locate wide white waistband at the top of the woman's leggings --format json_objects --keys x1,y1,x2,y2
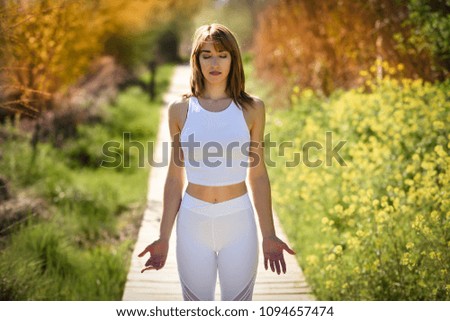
[{"x1": 180, "y1": 192, "x2": 253, "y2": 216}]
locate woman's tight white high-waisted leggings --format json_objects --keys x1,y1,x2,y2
[{"x1": 177, "y1": 192, "x2": 258, "y2": 301}]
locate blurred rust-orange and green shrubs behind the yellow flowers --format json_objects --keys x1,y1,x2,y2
[{"x1": 254, "y1": 0, "x2": 449, "y2": 94}]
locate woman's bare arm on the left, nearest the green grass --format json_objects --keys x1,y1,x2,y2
[{"x1": 139, "y1": 99, "x2": 184, "y2": 272}]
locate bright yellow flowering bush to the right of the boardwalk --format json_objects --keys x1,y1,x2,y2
[{"x1": 268, "y1": 61, "x2": 450, "y2": 300}]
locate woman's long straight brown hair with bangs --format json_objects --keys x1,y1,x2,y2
[{"x1": 184, "y1": 23, "x2": 254, "y2": 109}]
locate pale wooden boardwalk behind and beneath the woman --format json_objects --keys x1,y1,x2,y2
[{"x1": 123, "y1": 66, "x2": 314, "y2": 301}]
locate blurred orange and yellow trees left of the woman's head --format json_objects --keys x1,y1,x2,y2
[{"x1": 0, "y1": 0, "x2": 202, "y2": 116}]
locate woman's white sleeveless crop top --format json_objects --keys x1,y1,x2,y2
[{"x1": 180, "y1": 97, "x2": 250, "y2": 186}]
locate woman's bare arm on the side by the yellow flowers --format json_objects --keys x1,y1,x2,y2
[{"x1": 249, "y1": 99, "x2": 295, "y2": 274}]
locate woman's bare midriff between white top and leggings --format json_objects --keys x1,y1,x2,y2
[{"x1": 186, "y1": 181, "x2": 247, "y2": 204}]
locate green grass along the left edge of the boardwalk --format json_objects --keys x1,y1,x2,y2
[{"x1": 0, "y1": 66, "x2": 173, "y2": 300}]
